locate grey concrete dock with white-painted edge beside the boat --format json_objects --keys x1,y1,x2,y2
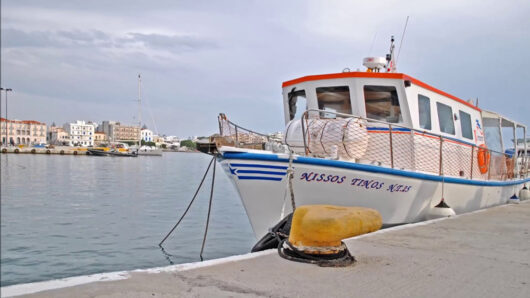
[{"x1": 2, "y1": 201, "x2": 530, "y2": 298}]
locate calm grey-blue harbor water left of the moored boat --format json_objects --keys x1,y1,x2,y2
[{"x1": 0, "y1": 153, "x2": 256, "y2": 286}]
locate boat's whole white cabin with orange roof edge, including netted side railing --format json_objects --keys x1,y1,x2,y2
[{"x1": 283, "y1": 71, "x2": 528, "y2": 180}]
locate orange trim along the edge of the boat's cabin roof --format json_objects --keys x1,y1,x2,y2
[{"x1": 282, "y1": 71, "x2": 481, "y2": 112}]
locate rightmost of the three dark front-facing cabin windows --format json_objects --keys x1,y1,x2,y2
[{"x1": 364, "y1": 85, "x2": 403, "y2": 123}]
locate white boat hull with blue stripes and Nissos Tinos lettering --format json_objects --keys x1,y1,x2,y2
[{"x1": 219, "y1": 151, "x2": 530, "y2": 238}]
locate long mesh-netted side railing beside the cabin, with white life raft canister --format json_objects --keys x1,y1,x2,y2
[{"x1": 299, "y1": 110, "x2": 528, "y2": 181}]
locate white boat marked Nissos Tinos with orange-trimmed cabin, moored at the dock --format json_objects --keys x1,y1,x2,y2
[{"x1": 196, "y1": 39, "x2": 530, "y2": 238}]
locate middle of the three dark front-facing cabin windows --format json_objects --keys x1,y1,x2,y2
[{"x1": 316, "y1": 86, "x2": 351, "y2": 118}]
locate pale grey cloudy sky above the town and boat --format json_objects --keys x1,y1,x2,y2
[{"x1": 0, "y1": 0, "x2": 530, "y2": 137}]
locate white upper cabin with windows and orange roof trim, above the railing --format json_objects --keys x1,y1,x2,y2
[{"x1": 282, "y1": 72, "x2": 484, "y2": 145}]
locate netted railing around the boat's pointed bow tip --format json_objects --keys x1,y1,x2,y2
[{"x1": 218, "y1": 113, "x2": 271, "y2": 149}]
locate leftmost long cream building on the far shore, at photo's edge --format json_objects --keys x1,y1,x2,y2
[{"x1": 0, "y1": 118, "x2": 46, "y2": 145}]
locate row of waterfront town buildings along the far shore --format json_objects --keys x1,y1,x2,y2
[{"x1": 0, "y1": 118, "x2": 188, "y2": 150}]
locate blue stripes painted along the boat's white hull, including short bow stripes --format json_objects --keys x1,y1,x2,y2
[{"x1": 223, "y1": 152, "x2": 530, "y2": 186}]
